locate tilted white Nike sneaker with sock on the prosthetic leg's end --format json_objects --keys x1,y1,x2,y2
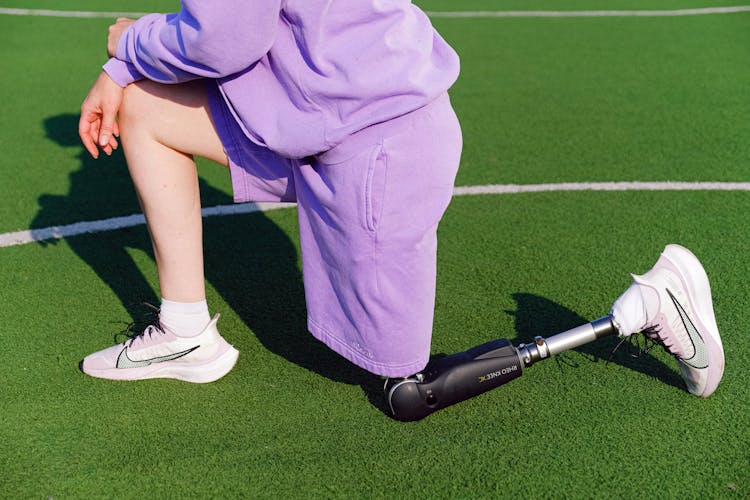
[{"x1": 612, "y1": 245, "x2": 724, "y2": 397}]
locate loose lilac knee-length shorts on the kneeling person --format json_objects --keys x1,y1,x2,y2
[{"x1": 208, "y1": 84, "x2": 462, "y2": 377}]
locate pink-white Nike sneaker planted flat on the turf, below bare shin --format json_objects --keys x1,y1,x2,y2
[{"x1": 80, "y1": 314, "x2": 239, "y2": 383}]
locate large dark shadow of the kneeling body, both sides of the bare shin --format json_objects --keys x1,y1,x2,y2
[{"x1": 31, "y1": 114, "x2": 385, "y2": 411}]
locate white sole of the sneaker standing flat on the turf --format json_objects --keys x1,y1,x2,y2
[{"x1": 80, "y1": 344, "x2": 240, "y2": 384}]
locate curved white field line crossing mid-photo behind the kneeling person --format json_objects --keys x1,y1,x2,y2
[{"x1": 0, "y1": 182, "x2": 750, "y2": 248}]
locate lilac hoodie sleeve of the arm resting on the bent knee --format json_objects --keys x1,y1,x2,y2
[{"x1": 104, "y1": 0, "x2": 281, "y2": 86}]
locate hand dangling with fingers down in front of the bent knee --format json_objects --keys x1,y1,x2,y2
[{"x1": 78, "y1": 71, "x2": 123, "y2": 158}]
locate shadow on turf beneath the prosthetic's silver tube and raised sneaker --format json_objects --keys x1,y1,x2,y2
[{"x1": 506, "y1": 293, "x2": 684, "y2": 388}]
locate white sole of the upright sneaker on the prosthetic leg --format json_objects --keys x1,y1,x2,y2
[{"x1": 662, "y1": 244, "x2": 724, "y2": 397}]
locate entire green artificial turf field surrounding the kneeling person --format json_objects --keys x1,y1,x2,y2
[{"x1": 0, "y1": 0, "x2": 750, "y2": 498}]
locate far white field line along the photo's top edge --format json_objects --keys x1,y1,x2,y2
[{"x1": 0, "y1": 5, "x2": 750, "y2": 19}]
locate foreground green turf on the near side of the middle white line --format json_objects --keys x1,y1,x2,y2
[{"x1": 0, "y1": 193, "x2": 750, "y2": 498}]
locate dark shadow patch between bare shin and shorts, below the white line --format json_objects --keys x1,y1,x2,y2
[{"x1": 204, "y1": 212, "x2": 379, "y2": 392}]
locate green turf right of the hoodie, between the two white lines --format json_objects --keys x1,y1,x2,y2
[{"x1": 436, "y1": 14, "x2": 750, "y2": 184}]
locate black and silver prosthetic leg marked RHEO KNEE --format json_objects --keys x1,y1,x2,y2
[{"x1": 385, "y1": 316, "x2": 618, "y2": 421}]
